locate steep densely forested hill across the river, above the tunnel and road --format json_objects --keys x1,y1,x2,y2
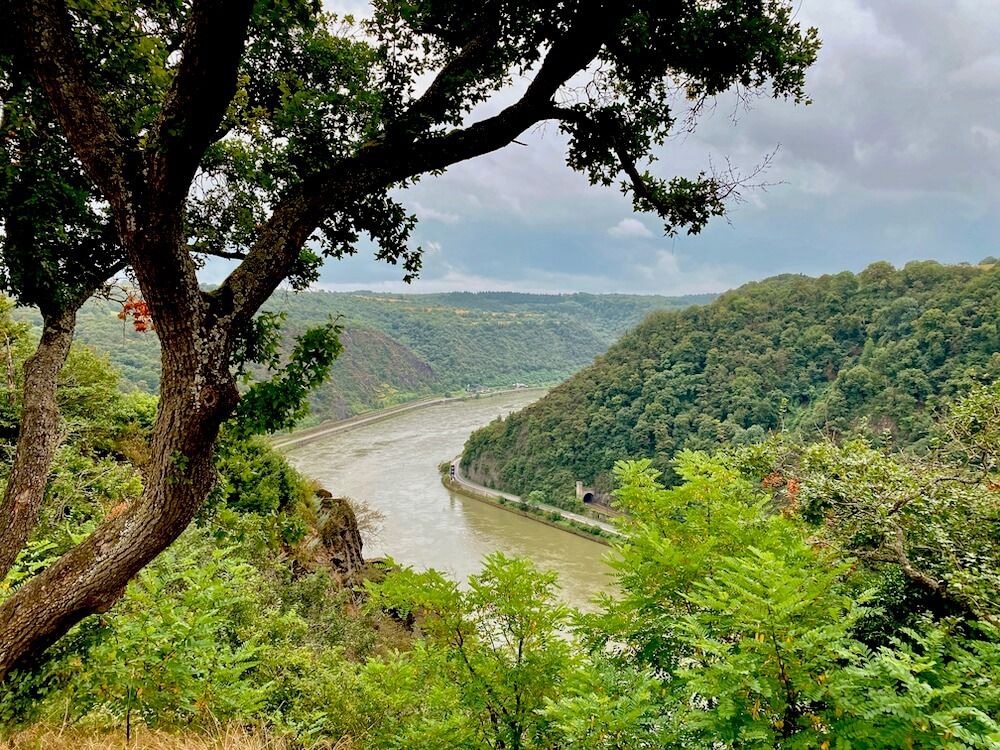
[{"x1": 463, "y1": 262, "x2": 1000, "y2": 497}]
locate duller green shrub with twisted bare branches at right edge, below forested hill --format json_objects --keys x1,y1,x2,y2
[{"x1": 800, "y1": 382, "x2": 1000, "y2": 626}]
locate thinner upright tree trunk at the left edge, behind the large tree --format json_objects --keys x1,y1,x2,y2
[{"x1": 0, "y1": 308, "x2": 76, "y2": 580}]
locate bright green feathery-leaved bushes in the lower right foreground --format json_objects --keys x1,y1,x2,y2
[{"x1": 582, "y1": 440, "x2": 1000, "y2": 750}]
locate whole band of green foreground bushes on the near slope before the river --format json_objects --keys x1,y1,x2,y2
[{"x1": 0, "y1": 296, "x2": 1000, "y2": 750}]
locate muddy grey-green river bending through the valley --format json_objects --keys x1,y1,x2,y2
[{"x1": 286, "y1": 391, "x2": 611, "y2": 608}]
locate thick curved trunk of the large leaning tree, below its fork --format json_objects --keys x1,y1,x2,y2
[{"x1": 0, "y1": 316, "x2": 238, "y2": 682}]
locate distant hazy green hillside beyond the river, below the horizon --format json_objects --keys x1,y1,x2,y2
[{"x1": 18, "y1": 292, "x2": 711, "y2": 422}]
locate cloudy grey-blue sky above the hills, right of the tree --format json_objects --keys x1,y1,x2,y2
[{"x1": 240, "y1": 0, "x2": 1000, "y2": 294}]
